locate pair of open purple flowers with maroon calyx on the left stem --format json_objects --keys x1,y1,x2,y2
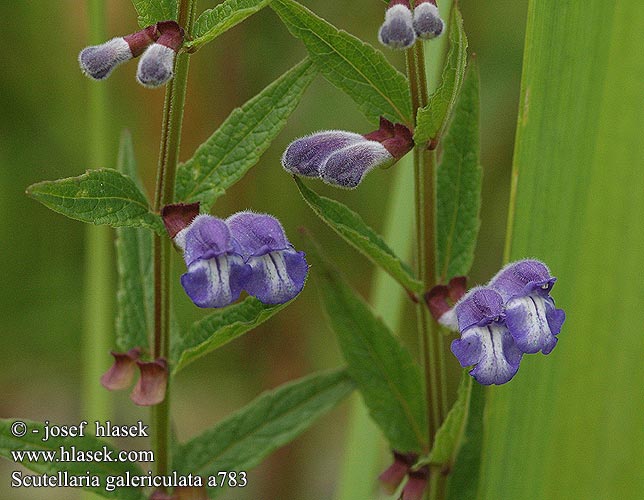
[{"x1": 162, "y1": 203, "x2": 309, "y2": 307}]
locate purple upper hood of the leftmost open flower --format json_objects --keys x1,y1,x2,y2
[{"x1": 174, "y1": 215, "x2": 235, "y2": 267}]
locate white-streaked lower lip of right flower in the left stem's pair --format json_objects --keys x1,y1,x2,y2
[{"x1": 245, "y1": 249, "x2": 309, "y2": 304}]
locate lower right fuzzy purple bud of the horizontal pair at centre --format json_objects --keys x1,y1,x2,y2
[{"x1": 320, "y1": 140, "x2": 395, "y2": 189}]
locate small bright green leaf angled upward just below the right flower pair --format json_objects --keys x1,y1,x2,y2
[{"x1": 427, "y1": 370, "x2": 473, "y2": 466}]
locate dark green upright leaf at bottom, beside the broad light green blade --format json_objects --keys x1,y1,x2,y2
[{"x1": 447, "y1": 375, "x2": 485, "y2": 500}]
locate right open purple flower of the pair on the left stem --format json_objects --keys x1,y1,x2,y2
[{"x1": 226, "y1": 212, "x2": 309, "y2": 304}]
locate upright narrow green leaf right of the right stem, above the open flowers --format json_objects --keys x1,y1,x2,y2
[{"x1": 436, "y1": 61, "x2": 482, "y2": 282}]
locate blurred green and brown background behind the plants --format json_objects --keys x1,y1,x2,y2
[{"x1": 0, "y1": 0, "x2": 527, "y2": 500}]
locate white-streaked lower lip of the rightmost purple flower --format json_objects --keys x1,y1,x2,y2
[{"x1": 506, "y1": 293, "x2": 565, "y2": 354}]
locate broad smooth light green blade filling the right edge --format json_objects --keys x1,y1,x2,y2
[{"x1": 480, "y1": 0, "x2": 644, "y2": 500}]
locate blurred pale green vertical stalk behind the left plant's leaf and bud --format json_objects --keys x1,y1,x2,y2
[{"x1": 82, "y1": 0, "x2": 114, "y2": 499}]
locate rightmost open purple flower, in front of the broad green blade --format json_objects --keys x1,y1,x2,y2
[{"x1": 489, "y1": 260, "x2": 566, "y2": 354}]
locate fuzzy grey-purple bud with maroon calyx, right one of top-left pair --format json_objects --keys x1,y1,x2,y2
[{"x1": 136, "y1": 21, "x2": 184, "y2": 88}]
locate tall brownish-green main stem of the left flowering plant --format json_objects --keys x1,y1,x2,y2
[{"x1": 152, "y1": 0, "x2": 195, "y2": 486}]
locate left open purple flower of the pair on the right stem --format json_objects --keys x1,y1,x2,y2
[{"x1": 452, "y1": 287, "x2": 523, "y2": 385}]
